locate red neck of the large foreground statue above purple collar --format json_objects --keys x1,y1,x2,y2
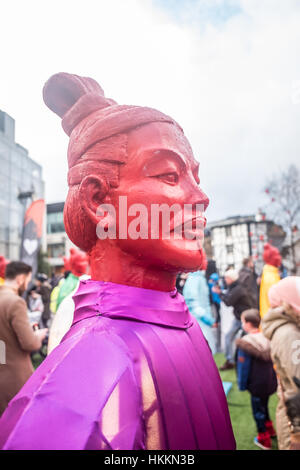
[{"x1": 90, "y1": 240, "x2": 176, "y2": 291}]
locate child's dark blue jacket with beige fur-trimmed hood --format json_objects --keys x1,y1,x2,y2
[{"x1": 236, "y1": 333, "x2": 277, "y2": 397}]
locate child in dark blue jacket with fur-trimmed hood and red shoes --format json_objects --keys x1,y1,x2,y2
[{"x1": 236, "y1": 308, "x2": 277, "y2": 450}]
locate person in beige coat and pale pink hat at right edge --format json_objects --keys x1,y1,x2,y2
[{"x1": 262, "y1": 276, "x2": 300, "y2": 450}]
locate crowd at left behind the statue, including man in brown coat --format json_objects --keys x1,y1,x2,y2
[{"x1": 0, "y1": 261, "x2": 84, "y2": 416}]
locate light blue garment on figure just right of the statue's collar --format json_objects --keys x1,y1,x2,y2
[{"x1": 183, "y1": 271, "x2": 216, "y2": 354}]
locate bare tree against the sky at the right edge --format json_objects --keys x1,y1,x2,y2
[{"x1": 264, "y1": 165, "x2": 300, "y2": 272}]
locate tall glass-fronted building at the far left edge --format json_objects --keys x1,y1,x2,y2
[{"x1": 0, "y1": 111, "x2": 44, "y2": 260}]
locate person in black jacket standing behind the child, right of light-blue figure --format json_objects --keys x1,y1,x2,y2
[{"x1": 213, "y1": 269, "x2": 252, "y2": 370}]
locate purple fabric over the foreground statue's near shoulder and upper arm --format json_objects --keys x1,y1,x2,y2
[{"x1": 0, "y1": 318, "x2": 143, "y2": 450}]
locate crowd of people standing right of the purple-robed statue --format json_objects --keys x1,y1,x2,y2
[{"x1": 177, "y1": 248, "x2": 300, "y2": 450}]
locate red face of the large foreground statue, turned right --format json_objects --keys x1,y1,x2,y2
[{"x1": 110, "y1": 123, "x2": 208, "y2": 271}]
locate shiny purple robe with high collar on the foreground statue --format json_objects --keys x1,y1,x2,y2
[{"x1": 0, "y1": 280, "x2": 235, "y2": 450}]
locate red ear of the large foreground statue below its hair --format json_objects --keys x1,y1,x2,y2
[{"x1": 79, "y1": 175, "x2": 109, "y2": 224}]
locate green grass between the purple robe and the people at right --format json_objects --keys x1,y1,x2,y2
[{"x1": 214, "y1": 354, "x2": 277, "y2": 450}]
